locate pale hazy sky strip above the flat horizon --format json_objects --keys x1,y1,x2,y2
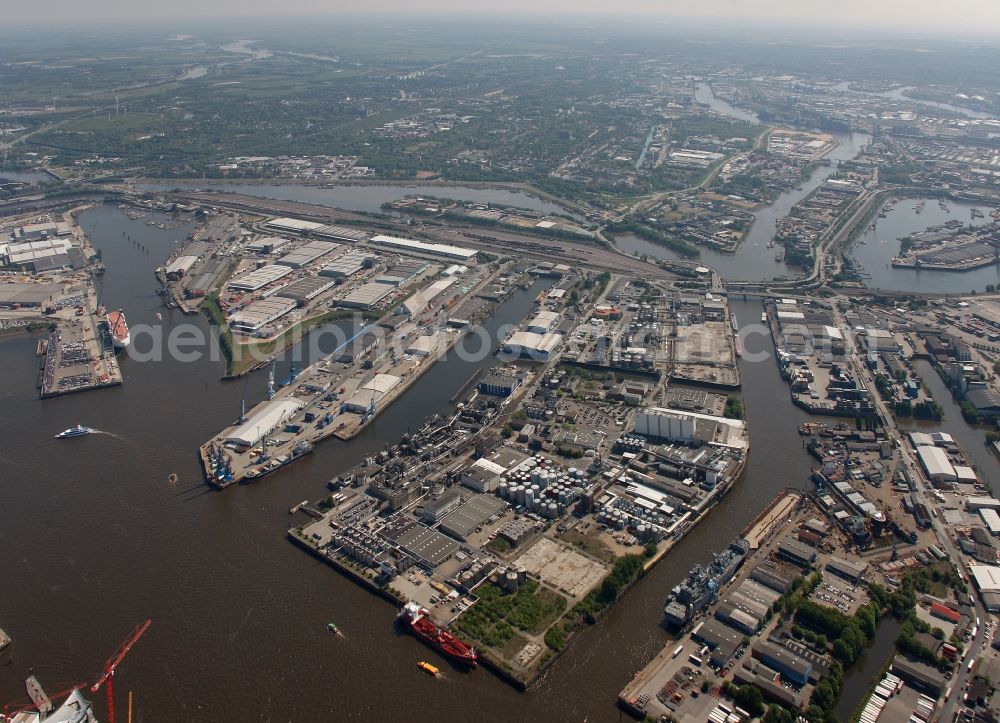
[{"x1": 11, "y1": 0, "x2": 1000, "y2": 35}]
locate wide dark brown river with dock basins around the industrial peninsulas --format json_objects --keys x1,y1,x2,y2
[{"x1": 0, "y1": 206, "x2": 832, "y2": 722}]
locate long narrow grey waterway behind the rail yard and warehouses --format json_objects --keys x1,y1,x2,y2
[{"x1": 138, "y1": 179, "x2": 580, "y2": 219}]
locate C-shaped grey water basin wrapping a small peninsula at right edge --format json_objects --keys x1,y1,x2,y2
[{"x1": 850, "y1": 198, "x2": 1000, "y2": 294}]
